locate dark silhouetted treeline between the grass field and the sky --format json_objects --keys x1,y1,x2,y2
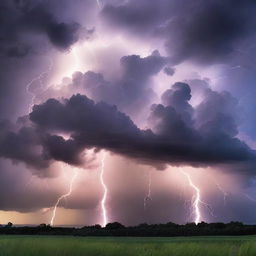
[{"x1": 0, "y1": 222, "x2": 256, "y2": 237}]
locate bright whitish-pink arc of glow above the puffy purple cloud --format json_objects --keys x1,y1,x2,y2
[{"x1": 50, "y1": 35, "x2": 155, "y2": 84}]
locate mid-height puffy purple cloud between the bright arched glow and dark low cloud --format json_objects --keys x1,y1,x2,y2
[{"x1": 36, "y1": 50, "x2": 169, "y2": 122}]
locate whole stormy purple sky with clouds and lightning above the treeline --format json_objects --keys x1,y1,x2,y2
[{"x1": 0, "y1": 0, "x2": 256, "y2": 226}]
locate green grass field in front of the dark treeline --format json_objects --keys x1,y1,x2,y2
[{"x1": 0, "y1": 236, "x2": 256, "y2": 256}]
